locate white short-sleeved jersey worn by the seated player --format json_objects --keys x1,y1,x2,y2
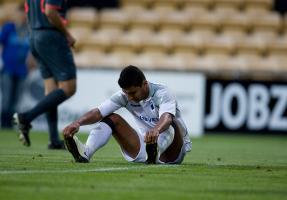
[{"x1": 98, "y1": 82, "x2": 190, "y2": 150}]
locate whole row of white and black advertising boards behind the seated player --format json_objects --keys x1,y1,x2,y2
[{"x1": 0, "y1": 69, "x2": 287, "y2": 137}]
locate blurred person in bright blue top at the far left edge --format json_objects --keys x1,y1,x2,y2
[{"x1": 0, "y1": 6, "x2": 32, "y2": 129}]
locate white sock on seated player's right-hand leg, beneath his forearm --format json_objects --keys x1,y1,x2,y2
[{"x1": 157, "y1": 127, "x2": 174, "y2": 155}]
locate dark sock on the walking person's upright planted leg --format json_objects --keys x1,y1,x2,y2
[{"x1": 46, "y1": 107, "x2": 60, "y2": 144}]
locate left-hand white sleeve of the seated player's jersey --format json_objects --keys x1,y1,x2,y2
[{"x1": 98, "y1": 91, "x2": 127, "y2": 117}]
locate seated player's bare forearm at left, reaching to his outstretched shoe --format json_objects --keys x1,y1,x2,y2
[{"x1": 63, "y1": 108, "x2": 103, "y2": 138}]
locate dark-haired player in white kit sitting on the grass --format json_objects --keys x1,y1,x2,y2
[{"x1": 63, "y1": 65, "x2": 191, "y2": 164}]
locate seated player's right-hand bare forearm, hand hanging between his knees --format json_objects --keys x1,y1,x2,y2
[{"x1": 144, "y1": 112, "x2": 173, "y2": 144}]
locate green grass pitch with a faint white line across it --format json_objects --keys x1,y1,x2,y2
[{"x1": 0, "y1": 130, "x2": 287, "y2": 200}]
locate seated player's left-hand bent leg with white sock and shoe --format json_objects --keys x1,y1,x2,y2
[{"x1": 71, "y1": 113, "x2": 145, "y2": 162}]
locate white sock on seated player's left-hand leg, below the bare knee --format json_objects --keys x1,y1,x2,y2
[{"x1": 86, "y1": 122, "x2": 112, "y2": 159}]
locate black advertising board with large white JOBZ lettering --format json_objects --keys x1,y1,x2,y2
[{"x1": 204, "y1": 79, "x2": 287, "y2": 134}]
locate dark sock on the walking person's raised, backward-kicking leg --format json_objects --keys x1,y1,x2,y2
[{"x1": 21, "y1": 89, "x2": 67, "y2": 123}]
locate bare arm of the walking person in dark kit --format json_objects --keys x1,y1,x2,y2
[{"x1": 45, "y1": 5, "x2": 76, "y2": 47}]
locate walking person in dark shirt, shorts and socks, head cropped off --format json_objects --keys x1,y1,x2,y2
[{"x1": 13, "y1": 0, "x2": 76, "y2": 149}]
